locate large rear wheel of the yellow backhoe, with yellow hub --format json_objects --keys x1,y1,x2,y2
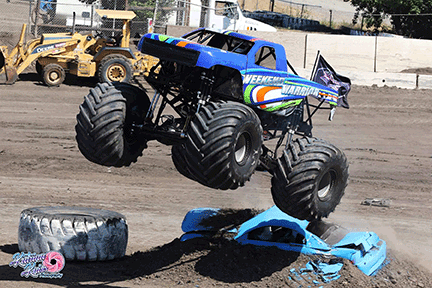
[{"x1": 98, "y1": 54, "x2": 133, "y2": 83}]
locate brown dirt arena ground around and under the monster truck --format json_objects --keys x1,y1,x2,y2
[{"x1": 0, "y1": 73, "x2": 432, "y2": 287}]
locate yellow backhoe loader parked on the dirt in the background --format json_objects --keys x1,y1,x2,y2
[{"x1": 0, "y1": 10, "x2": 157, "y2": 86}]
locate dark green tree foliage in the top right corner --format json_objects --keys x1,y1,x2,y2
[{"x1": 344, "y1": 0, "x2": 432, "y2": 39}]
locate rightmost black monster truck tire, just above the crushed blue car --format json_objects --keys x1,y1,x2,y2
[{"x1": 271, "y1": 138, "x2": 348, "y2": 221}]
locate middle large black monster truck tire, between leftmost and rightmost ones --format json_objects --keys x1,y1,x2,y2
[{"x1": 173, "y1": 102, "x2": 262, "y2": 190}]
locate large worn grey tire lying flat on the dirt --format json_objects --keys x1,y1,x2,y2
[{"x1": 18, "y1": 206, "x2": 128, "y2": 261}]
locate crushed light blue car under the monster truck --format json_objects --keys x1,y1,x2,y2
[{"x1": 181, "y1": 206, "x2": 386, "y2": 276}]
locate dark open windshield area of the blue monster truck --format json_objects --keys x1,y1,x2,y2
[{"x1": 183, "y1": 30, "x2": 254, "y2": 54}]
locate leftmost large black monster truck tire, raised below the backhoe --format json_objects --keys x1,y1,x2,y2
[{"x1": 75, "y1": 83, "x2": 150, "y2": 167}]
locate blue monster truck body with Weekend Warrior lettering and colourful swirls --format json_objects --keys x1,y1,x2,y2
[{"x1": 138, "y1": 28, "x2": 338, "y2": 112}]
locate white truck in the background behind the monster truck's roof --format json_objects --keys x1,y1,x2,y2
[{"x1": 168, "y1": 0, "x2": 277, "y2": 32}]
